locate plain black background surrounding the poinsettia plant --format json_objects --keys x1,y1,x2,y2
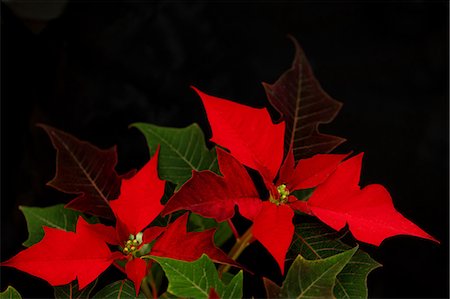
[{"x1": 1, "y1": 1, "x2": 449, "y2": 298}]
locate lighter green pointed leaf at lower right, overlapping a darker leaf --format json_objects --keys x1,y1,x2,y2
[{"x1": 280, "y1": 247, "x2": 358, "y2": 298}]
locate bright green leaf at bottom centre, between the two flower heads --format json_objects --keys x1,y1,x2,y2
[{"x1": 152, "y1": 254, "x2": 243, "y2": 299}]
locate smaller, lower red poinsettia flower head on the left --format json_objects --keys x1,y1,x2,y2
[{"x1": 2, "y1": 151, "x2": 236, "y2": 294}]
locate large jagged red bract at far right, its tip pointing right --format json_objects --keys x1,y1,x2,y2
[{"x1": 305, "y1": 154, "x2": 438, "y2": 246}]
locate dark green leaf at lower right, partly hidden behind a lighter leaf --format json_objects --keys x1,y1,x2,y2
[{"x1": 287, "y1": 222, "x2": 381, "y2": 299}]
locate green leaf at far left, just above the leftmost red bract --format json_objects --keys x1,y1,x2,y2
[{"x1": 19, "y1": 204, "x2": 81, "y2": 247}]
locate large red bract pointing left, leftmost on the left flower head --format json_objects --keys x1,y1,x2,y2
[{"x1": 1, "y1": 217, "x2": 113, "y2": 289}]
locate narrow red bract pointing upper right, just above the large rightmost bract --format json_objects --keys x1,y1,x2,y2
[{"x1": 277, "y1": 151, "x2": 348, "y2": 191}]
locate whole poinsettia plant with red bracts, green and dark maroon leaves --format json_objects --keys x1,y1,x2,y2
[{"x1": 1, "y1": 40, "x2": 438, "y2": 298}]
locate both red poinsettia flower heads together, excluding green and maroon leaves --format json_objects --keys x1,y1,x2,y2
[{"x1": 1, "y1": 87, "x2": 436, "y2": 293}]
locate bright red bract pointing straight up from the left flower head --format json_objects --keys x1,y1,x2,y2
[{"x1": 110, "y1": 149, "x2": 165, "y2": 240}]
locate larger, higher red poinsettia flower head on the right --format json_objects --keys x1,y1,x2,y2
[{"x1": 163, "y1": 90, "x2": 438, "y2": 272}]
